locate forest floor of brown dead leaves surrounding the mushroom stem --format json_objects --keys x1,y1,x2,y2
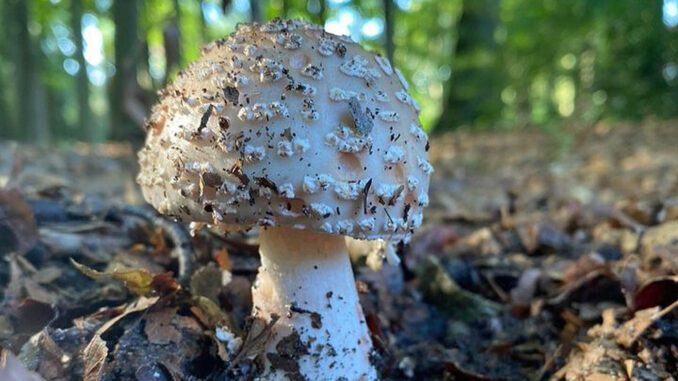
[{"x1": 0, "y1": 121, "x2": 678, "y2": 381}]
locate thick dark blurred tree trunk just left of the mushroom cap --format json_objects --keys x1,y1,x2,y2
[{"x1": 111, "y1": 0, "x2": 143, "y2": 141}]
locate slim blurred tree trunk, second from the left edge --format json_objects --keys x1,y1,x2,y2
[{"x1": 71, "y1": 0, "x2": 96, "y2": 142}]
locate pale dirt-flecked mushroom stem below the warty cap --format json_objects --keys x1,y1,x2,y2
[{"x1": 252, "y1": 227, "x2": 377, "y2": 380}]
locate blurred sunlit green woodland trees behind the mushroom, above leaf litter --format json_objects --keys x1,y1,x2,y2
[{"x1": 0, "y1": 0, "x2": 678, "y2": 144}]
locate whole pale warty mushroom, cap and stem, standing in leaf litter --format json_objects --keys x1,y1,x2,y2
[{"x1": 138, "y1": 20, "x2": 433, "y2": 380}]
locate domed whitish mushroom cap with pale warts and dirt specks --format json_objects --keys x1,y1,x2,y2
[{"x1": 138, "y1": 20, "x2": 432, "y2": 240}]
